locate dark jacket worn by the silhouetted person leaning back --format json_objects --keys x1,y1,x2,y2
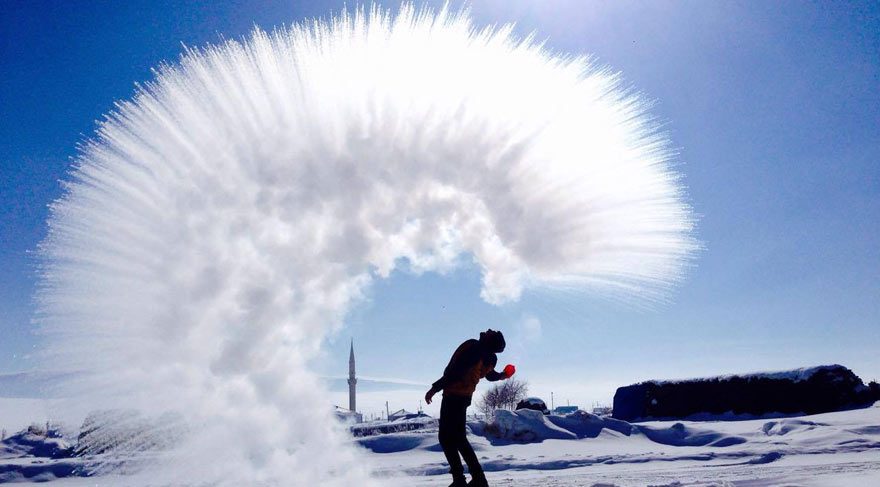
[{"x1": 433, "y1": 338, "x2": 505, "y2": 397}]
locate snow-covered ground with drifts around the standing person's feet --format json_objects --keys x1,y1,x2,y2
[{"x1": 0, "y1": 403, "x2": 880, "y2": 487}]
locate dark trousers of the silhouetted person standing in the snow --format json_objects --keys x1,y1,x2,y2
[{"x1": 440, "y1": 394, "x2": 483, "y2": 478}]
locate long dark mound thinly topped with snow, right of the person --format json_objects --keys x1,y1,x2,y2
[{"x1": 614, "y1": 365, "x2": 880, "y2": 421}]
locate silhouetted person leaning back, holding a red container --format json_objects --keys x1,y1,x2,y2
[{"x1": 425, "y1": 328, "x2": 516, "y2": 487}]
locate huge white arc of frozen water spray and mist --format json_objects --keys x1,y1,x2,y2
[{"x1": 38, "y1": 6, "x2": 696, "y2": 486}]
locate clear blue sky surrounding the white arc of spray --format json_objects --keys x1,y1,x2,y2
[{"x1": 0, "y1": 0, "x2": 880, "y2": 408}]
